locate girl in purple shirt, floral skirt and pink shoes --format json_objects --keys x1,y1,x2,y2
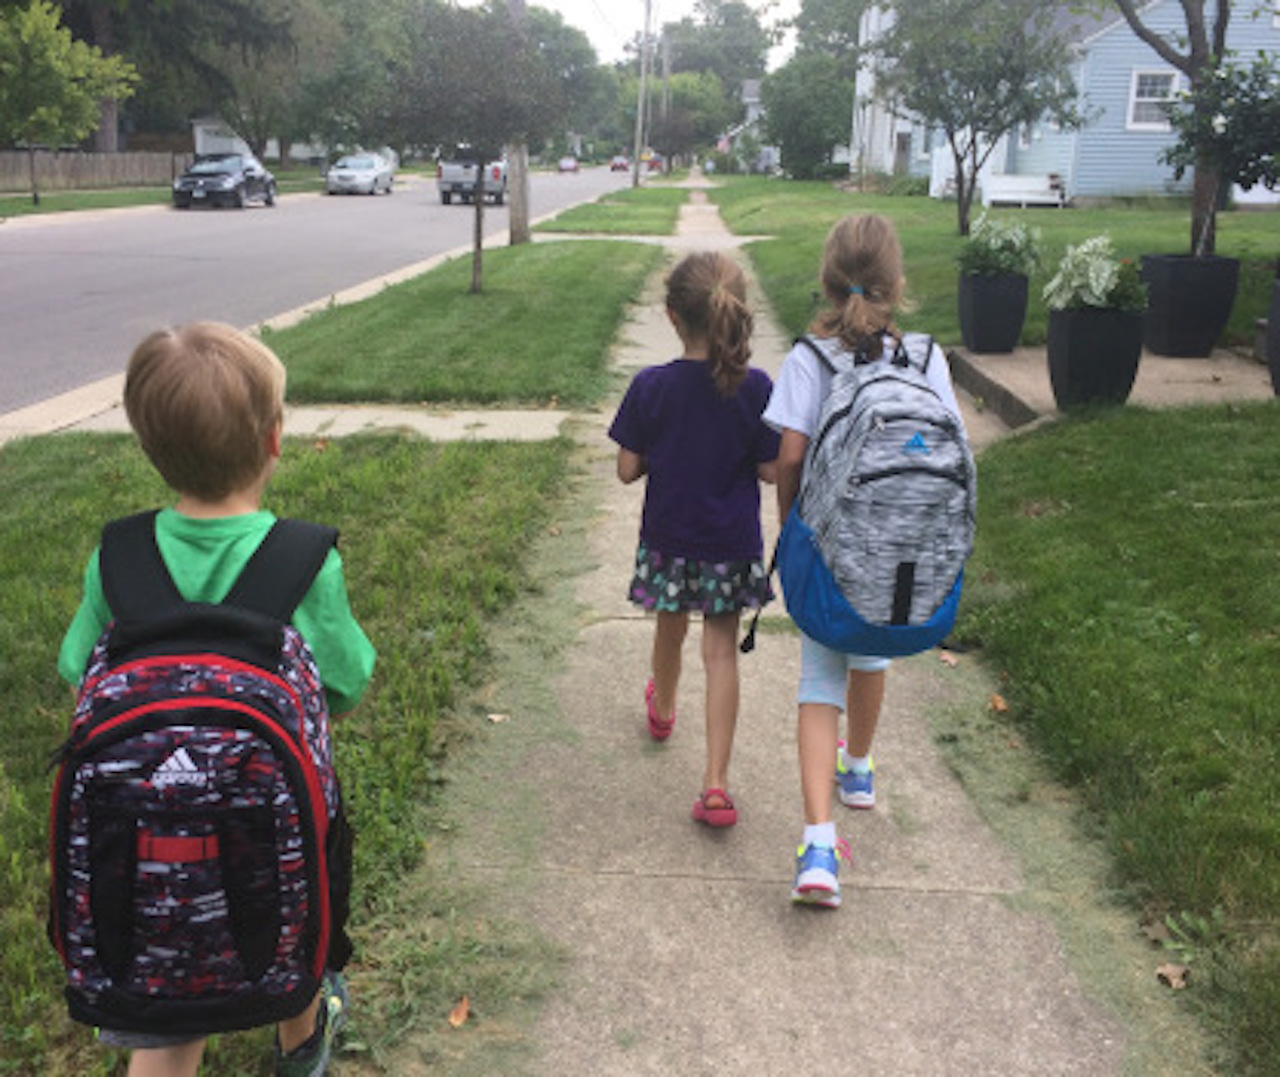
[{"x1": 609, "y1": 254, "x2": 778, "y2": 826}]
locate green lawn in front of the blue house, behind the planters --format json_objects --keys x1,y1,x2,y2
[{"x1": 712, "y1": 178, "x2": 1280, "y2": 347}]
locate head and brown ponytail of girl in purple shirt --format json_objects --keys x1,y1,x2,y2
[{"x1": 667, "y1": 252, "x2": 754, "y2": 397}]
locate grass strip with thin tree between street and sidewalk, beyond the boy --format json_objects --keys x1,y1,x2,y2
[{"x1": 264, "y1": 241, "x2": 662, "y2": 407}]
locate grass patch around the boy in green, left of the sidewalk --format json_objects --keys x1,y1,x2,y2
[{"x1": 0, "y1": 435, "x2": 572, "y2": 1077}]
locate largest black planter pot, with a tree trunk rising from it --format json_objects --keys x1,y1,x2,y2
[{"x1": 1142, "y1": 255, "x2": 1240, "y2": 359}]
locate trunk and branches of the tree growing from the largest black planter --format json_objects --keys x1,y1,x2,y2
[{"x1": 1091, "y1": 0, "x2": 1272, "y2": 255}]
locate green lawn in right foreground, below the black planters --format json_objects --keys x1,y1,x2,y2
[{"x1": 960, "y1": 403, "x2": 1280, "y2": 1074}]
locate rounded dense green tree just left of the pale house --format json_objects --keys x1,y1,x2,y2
[{"x1": 760, "y1": 53, "x2": 854, "y2": 179}]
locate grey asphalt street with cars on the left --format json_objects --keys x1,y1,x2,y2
[{"x1": 0, "y1": 168, "x2": 628, "y2": 414}]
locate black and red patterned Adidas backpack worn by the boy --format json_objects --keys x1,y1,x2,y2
[{"x1": 50, "y1": 512, "x2": 351, "y2": 1035}]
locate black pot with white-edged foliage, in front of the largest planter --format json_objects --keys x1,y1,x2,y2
[{"x1": 1048, "y1": 307, "x2": 1143, "y2": 409}]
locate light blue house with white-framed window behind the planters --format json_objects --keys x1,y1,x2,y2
[{"x1": 984, "y1": 0, "x2": 1280, "y2": 201}]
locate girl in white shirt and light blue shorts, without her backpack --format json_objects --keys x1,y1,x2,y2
[{"x1": 764, "y1": 215, "x2": 960, "y2": 908}]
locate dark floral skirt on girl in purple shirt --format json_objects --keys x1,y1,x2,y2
[{"x1": 627, "y1": 542, "x2": 773, "y2": 616}]
